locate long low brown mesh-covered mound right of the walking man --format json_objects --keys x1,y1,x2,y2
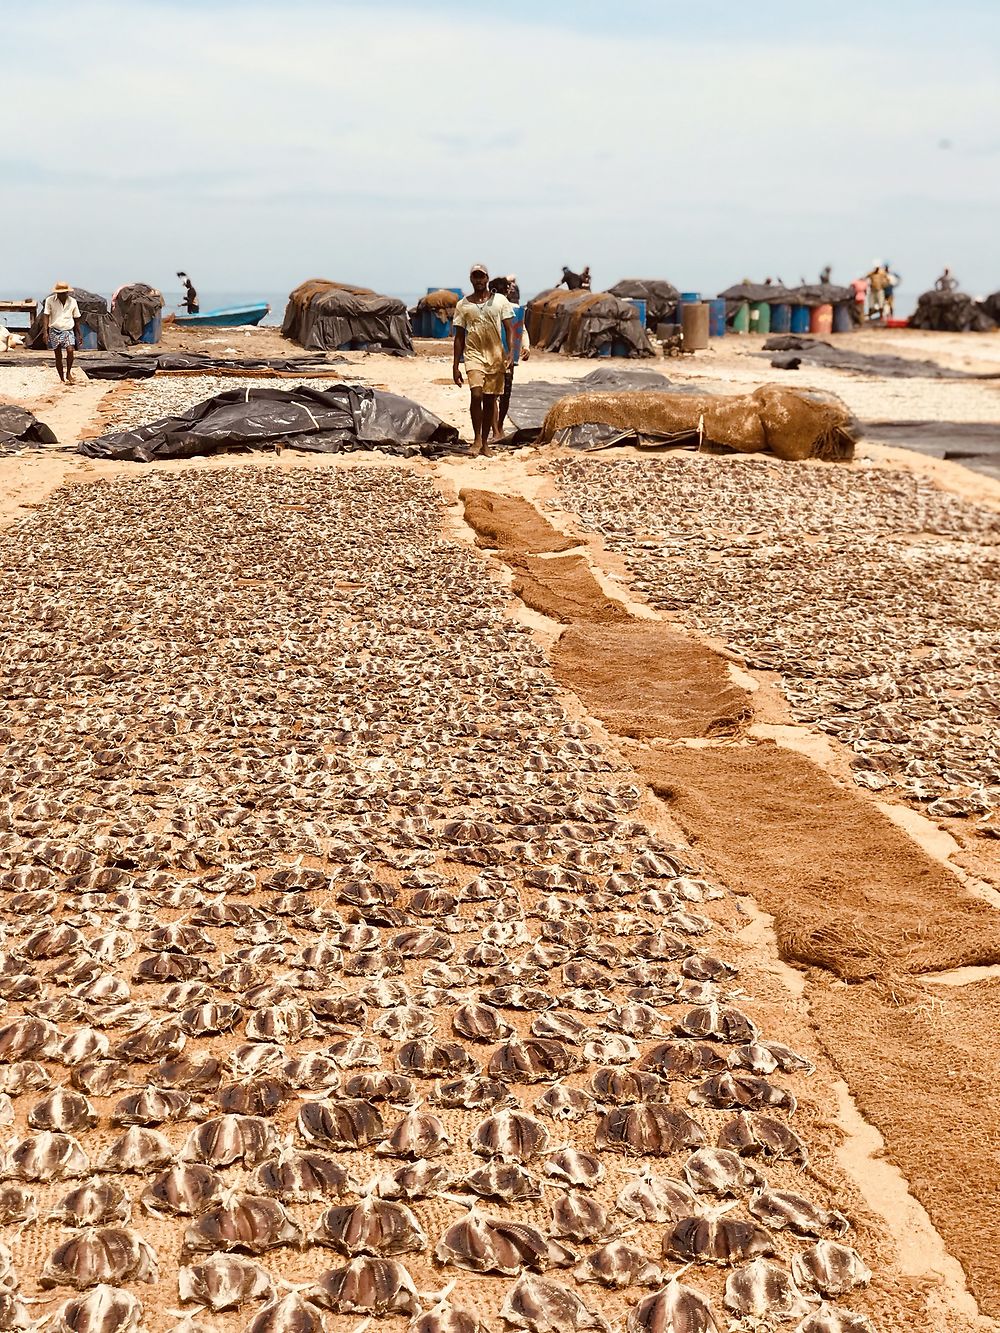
[{"x1": 541, "y1": 384, "x2": 860, "y2": 460}]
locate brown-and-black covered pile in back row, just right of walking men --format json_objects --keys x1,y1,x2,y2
[{"x1": 524, "y1": 288, "x2": 653, "y2": 357}]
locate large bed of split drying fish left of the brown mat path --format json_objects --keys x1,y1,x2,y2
[{"x1": 0, "y1": 468, "x2": 868, "y2": 1333}]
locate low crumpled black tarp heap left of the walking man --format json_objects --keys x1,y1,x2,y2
[{"x1": 79, "y1": 384, "x2": 459, "y2": 463}]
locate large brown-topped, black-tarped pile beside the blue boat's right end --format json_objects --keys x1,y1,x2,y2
[{"x1": 281, "y1": 277, "x2": 413, "y2": 352}]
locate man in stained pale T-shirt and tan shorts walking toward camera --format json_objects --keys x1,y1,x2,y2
[{"x1": 452, "y1": 264, "x2": 513, "y2": 459}]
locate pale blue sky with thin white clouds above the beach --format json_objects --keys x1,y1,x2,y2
[{"x1": 0, "y1": 0, "x2": 1000, "y2": 296}]
